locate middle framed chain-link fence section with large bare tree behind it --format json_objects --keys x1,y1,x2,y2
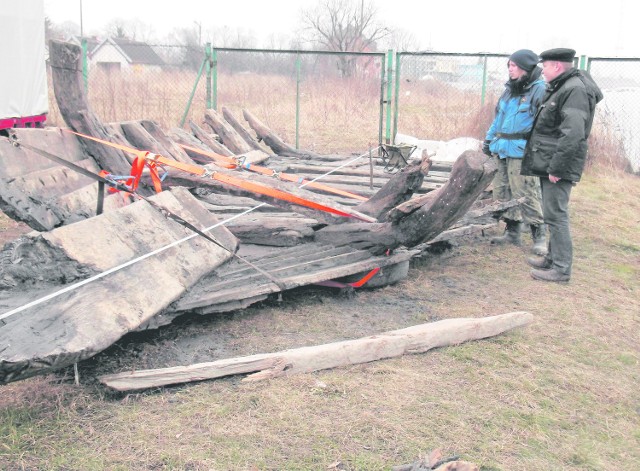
[{"x1": 213, "y1": 49, "x2": 385, "y2": 153}]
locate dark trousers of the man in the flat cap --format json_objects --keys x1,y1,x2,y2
[{"x1": 540, "y1": 177, "x2": 575, "y2": 275}]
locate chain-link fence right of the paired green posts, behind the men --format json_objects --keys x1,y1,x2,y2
[{"x1": 393, "y1": 52, "x2": 640, "y2": 172}]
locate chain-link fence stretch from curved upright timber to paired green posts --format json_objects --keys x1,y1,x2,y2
[{"x1": 48, "y1": 40, "x2": 388, "y2": 153}]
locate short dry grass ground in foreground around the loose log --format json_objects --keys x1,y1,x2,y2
[{"x1": 0, "y1": 167, "x2": 640, "y2": 471}]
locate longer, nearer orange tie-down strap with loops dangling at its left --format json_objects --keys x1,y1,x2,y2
[{"x1": 69, "y1": 130, "x2": 375, "y2": 222}]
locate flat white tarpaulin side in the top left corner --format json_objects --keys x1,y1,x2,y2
[{"x1": 0, "y1": 0, "x2": 49, "y2": 119}]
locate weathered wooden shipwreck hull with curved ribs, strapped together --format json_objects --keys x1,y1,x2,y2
[{"x1": 0, "y1": 41, "x2": 509, "y2": 383}]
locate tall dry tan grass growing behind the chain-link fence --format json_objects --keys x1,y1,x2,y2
[{"x1": 49, "y1": 71, "x2": 495, "y2": 154}]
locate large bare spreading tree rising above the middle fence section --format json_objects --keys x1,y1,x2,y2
[{"x1": 302, "y1": 0, "x2": 390, "y2": 76}]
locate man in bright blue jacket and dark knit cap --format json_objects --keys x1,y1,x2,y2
[{"x1": 482, "y1": 49, "x2": 547, "y2": 255}]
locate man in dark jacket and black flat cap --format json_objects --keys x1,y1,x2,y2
[{"x1": 521, "y1": 48, "x2": 602, "y2": 281}]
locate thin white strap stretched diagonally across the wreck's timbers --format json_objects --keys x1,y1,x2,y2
[{"x1": 0, "y1": 148, "x2": 378, "y2": 321}]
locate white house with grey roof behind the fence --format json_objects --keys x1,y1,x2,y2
[{"x1": 89, "y1": 38, "x2": 164, "y2": 73}]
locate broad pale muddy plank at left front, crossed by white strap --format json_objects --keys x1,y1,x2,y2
[{"x1": 0, "y1": 188, "x2": 237, "y2": 383}]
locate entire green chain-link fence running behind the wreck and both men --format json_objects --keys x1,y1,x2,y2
[{"x1": 49, "y1": 40, "x2": 640, "y2": 171}]
